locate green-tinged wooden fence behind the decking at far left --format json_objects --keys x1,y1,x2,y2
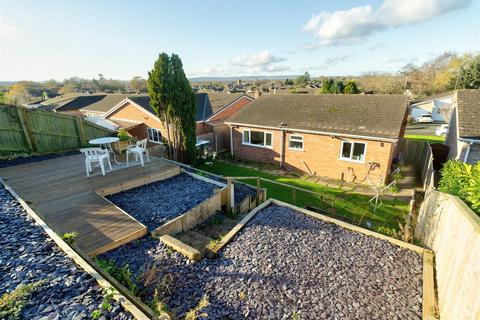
[{"x1": 0, "y1": 105, "x2": 112, "y2": 153}]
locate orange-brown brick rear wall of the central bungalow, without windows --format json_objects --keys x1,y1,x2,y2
[{"x1": 233, "y1": 128, "x2": 394, "y2": 184}]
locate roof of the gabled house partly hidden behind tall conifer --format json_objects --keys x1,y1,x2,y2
[{"x1": 52, "y1": 93, "x2": 212, "y2": 121}]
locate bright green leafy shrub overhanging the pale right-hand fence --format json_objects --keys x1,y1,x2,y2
[{"x1": 438, "y1": 160, "x2": 480, "y2": 213}]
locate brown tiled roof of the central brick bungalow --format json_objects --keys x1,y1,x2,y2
[{"x1": 226, "y1": 94, "x2": 408, "y2": 139}]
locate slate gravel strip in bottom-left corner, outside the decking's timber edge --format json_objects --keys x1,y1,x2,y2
[{"x1": 0, "y1": 185, "x2": 132, "y2": 319}]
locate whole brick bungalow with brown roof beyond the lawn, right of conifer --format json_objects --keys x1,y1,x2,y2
[{"x1": 226, "y1": 95, "x2": 409, "y2": 184}]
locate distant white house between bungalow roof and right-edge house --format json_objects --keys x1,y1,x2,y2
[{"x1": 410, "y1": 92, "x2": 453, "y2": 122}]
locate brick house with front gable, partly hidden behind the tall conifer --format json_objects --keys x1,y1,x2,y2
[{"x1": 48, "y1": 93, "x2": 212, "y2": 143}]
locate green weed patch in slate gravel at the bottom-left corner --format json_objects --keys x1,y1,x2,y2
[{"x1": 0, "y1": 280, "x2": 45, "y2": 319}]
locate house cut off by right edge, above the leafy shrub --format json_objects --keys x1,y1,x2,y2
[{"x1": 445, "y1": 90, "x2": 480, "y2": 164}]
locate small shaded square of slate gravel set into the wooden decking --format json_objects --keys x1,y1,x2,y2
[{"x1": 108, "y1": 173, "x2": 219, "y2": 231}]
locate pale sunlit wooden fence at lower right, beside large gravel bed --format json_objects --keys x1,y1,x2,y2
[{"x1": 415, "y1": 191, "x2": 480, "y2": 320}]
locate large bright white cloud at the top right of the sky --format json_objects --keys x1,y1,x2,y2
[{"x1": 303, "y1": 0, "x2": 472, "y2": 49}]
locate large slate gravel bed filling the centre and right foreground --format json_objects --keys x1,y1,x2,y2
[{"x1": 102, "y1": 205, "x2": 422, "y2": 319}]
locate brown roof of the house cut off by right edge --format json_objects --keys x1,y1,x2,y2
[{"x1": 457, "y1": 90, "x2": 480, "y2": 140}]
